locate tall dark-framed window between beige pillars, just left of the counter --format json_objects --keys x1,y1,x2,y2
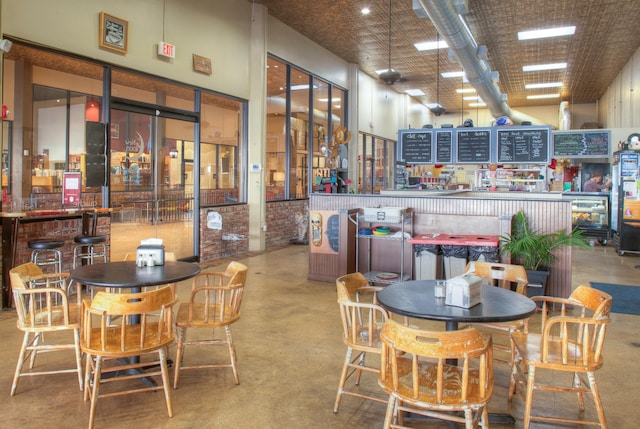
[{"x1": 266, "y1": 57, "x2": 347, "y2": 200}]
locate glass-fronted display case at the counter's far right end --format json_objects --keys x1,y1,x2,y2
[{"x1": 563, "y1": 192, "x2": 610, "y2": 245}]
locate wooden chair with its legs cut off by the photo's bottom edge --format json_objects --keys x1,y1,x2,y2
[{"x1": 378, "y1": 319, "x2": 493, "y2": 429}]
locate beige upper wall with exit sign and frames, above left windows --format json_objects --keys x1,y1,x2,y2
[{"x1": 2, "y1": 0, "x2": 251, "y2": 99}]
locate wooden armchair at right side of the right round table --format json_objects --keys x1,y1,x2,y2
[{"x1": 509, "y1": 286, "x2": 612, "y2": 429}]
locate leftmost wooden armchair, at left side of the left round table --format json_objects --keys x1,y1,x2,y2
[{"x1": 9, "y1": 262, "x2": 83, "y2": 396}]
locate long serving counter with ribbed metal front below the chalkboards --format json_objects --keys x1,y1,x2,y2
[{"x1": 309, "y1": 190, "x2": 572, "y2": 297}]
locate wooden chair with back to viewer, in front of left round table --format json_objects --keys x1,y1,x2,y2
[{"x1": 80, "y1": 287, "x2": 176, "y2": 429}]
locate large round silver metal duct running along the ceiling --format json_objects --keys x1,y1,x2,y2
[{"x1": 413, "y1": 0, "x2": 538, "y2": 124}]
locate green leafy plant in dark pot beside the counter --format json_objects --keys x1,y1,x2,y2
[{"x1": 500, "y1": 211, "x2": 590, "y2": 295}]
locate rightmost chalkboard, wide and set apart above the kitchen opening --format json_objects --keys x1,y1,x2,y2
[{"x1": 553, "y1": 130, "x2": 611, "y2": 158}]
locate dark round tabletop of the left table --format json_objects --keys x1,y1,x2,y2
[{"x1": 71, "y1": 261, "x2": 200, "y2": 288}]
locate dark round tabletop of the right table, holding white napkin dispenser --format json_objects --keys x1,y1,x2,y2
[{"x1": 378, "y1": 280, "x2": 536, "y2": 323}]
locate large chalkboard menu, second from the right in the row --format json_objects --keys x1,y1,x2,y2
[{"x1": 496, "y1": 127, "x2": 551, "y2": 164}]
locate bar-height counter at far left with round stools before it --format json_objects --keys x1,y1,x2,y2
[{"x1": 0, "y1": 209, "x2": 111, "y2": 307}]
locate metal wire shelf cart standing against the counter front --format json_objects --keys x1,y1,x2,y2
[{"x1": 352, "y1": 207, "x2": 413, "y2": 284}]
